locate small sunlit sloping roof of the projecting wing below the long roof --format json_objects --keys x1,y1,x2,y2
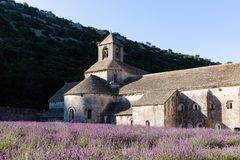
[{"x1": 132, "y1": 90, "x2": 176, "y2": 106}]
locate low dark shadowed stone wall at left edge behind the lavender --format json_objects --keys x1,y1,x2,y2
[{"x1": 0, "y1": 107, "x2": 42, "y2": 121}]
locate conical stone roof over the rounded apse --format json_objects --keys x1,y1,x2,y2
[{"x1": 65, "y1": 75, "x2": 111, "y2": 95}]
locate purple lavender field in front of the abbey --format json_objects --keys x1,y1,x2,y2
[{"x1": 0, "y1": 122, "x2": 240, "y2": 160}]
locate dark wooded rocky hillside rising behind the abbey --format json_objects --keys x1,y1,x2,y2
[{"x1": 0, "y1": 0, "x2": 219, "y2": 109}]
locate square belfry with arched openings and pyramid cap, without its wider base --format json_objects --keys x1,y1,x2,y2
[{"x1": 98, "y1": 33, "x2": 123, "y2": 62}]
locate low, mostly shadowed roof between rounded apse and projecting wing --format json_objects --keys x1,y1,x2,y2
[{"x1": 105, "y1": 101, "x2": 132, "y2": 116}]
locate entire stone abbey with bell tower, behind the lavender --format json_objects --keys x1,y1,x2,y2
[{"x1": 43, "y1": 33, "x2": 240, "y2": 129}]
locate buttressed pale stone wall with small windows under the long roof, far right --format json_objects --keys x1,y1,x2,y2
[{"x1": 176, "y1": 86, "x2": 240, "y2": 129}]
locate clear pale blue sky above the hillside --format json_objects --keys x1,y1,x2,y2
[{"x1": 16, "y1": 0, "x2": 240, "y2": 63}]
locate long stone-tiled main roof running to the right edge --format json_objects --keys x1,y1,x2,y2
[{"x1": 120, "y1": 63, "x2": 240, "y2": 94}]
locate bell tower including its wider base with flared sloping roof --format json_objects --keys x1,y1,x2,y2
[{"x1": 85, "y1": 33, "x2": 146, "y2": 86}]
